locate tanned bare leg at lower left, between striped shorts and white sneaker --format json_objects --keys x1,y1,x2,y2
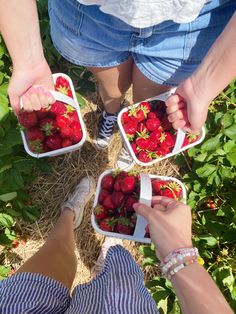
[{"x1": 17, "y1": 209, "x2": 77, "y2": 289}]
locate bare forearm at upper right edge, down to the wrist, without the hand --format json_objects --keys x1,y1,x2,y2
[{"x1": 192, "y1": 13, "x2": 236, "y2": 101}]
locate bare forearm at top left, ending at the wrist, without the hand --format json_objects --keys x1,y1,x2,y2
[{"x1": 0, "y1": 0, "x2": 44, "y2": 68}]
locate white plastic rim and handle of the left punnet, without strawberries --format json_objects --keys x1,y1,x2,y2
[{"x1": 20, "y1": 73, "x2": 86, "y2": 158}]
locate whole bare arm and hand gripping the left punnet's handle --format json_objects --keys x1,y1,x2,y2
[{"x1": 0, "y1": 0, "x2": 53, "y2": 112}]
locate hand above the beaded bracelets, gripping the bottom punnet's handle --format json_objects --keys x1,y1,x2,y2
[{"x1": 133, "y1": 196, "x2": 192, "y2": 261}]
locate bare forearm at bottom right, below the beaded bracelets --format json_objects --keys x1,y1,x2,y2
[{"x1": 172, "y1": 263, "x2": 233, "y2": 314}]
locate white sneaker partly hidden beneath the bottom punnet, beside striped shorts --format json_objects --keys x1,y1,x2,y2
[{"x1": 91, "y1": 237, "x2": 123, "y2": 278}]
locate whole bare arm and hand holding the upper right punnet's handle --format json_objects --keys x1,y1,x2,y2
[{"x1": 166, "y1": 13, "x2": 236, "y2": 132}]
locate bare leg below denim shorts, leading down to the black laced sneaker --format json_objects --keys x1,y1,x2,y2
[{"x1": 88, "y1": 59, "x2": 133, "y2": 114}]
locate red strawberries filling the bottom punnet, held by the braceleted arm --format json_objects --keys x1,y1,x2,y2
[{"x1": 93, "y1": 171, "x2": 183, "y2": 237}]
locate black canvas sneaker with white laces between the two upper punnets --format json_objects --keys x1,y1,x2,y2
[{"x1": 95, "y1": 111, "x2": 118, "y2": 149}]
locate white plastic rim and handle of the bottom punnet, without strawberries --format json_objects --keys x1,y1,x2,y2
[{"x1": 91, "y1": 170, "x2": 186, "y2": 243}]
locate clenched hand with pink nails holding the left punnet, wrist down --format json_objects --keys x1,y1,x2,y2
[{"x1": 8, "y1": 60, "x2": 55, "y2": 114}]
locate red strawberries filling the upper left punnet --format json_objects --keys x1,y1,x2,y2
[{"x1": 18, "y1": 76, "x2": 83, "y2": 153}]
